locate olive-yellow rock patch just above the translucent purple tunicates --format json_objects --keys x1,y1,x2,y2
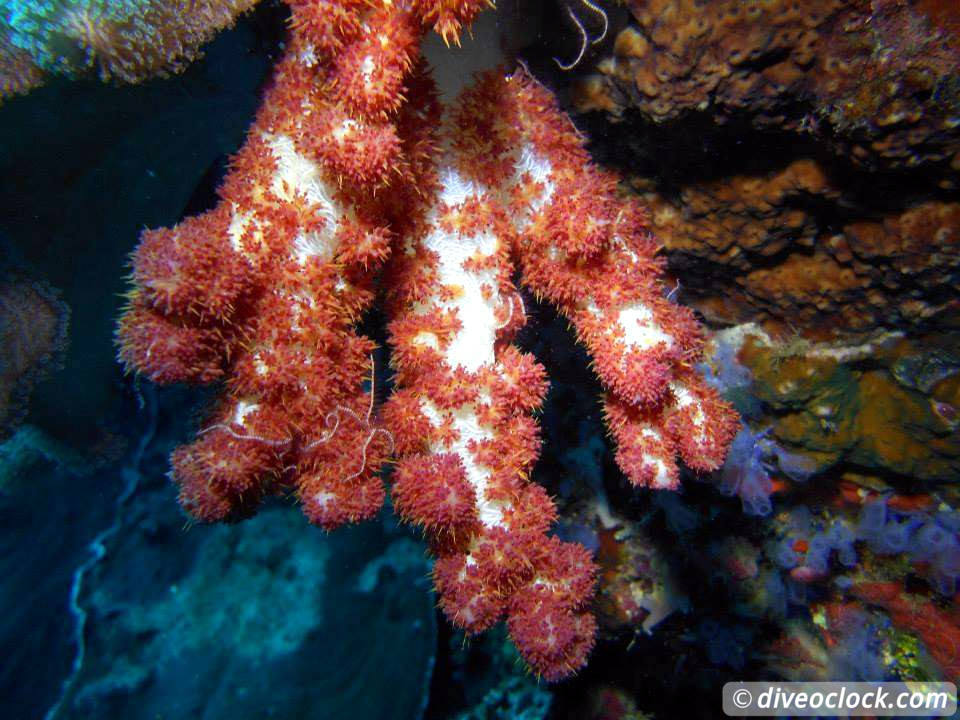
[{"x1": 727, "y1": 326, "x2": 960, "y2": 482}]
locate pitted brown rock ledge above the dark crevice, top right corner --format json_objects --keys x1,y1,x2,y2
[{"x1": 575, "y1": 0, "x2": 960, "y2": 171}]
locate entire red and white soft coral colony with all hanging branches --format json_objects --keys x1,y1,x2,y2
[{"x1": 118, "y1": 0, "x2": 738, "y2": 680}]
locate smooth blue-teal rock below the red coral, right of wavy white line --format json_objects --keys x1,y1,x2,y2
[{"x1": 64, "y1": 507, "x2": 436, "y2": 720}]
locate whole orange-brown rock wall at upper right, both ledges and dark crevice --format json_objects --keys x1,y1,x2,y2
[{"x1": 574, "y1": 0, "x2": 960, "y2": 339}]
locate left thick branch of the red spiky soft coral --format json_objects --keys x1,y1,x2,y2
[{"x1": 118, "y1": 0, "x2": 436, "y2": 528}]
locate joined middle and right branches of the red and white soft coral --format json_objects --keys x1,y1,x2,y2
[{"x1": 385, "y1": 71, "x2": 736, "y2": 680}]
